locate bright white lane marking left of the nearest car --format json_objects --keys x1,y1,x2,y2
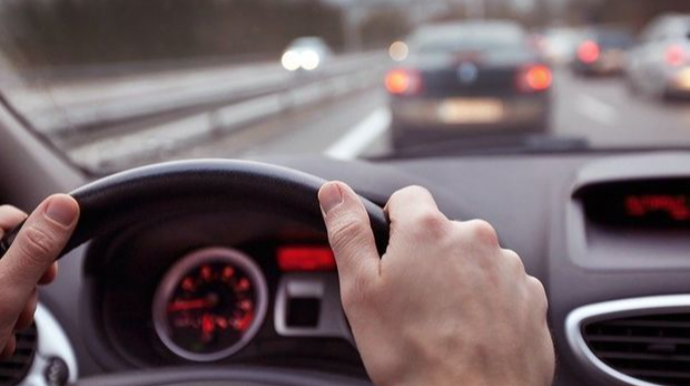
[{"x1": 324, "y1": 107, "x2": 391, "y2": 160}]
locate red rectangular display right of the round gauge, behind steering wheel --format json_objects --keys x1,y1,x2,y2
[{"x1": 277, "y1": 246, "x2": 336, "y2": 272}]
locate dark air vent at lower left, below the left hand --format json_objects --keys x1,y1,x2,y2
[{"x1": 0, "y1": 325, "x2": 38, "y2": 386}]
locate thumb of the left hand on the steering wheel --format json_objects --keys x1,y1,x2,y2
[{"x1": 0, "y1": 195, "x2": 79, "y2": 314}]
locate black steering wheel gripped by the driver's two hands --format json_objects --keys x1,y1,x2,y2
[{"x1": 0, "y1": 160, "x2": 388, "y2": 386}]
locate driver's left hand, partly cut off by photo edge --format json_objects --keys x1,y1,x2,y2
[{"x1": 0, "y1": 194, "x2": 79, "y2": 359}]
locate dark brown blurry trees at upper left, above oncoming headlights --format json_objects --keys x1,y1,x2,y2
[{"x1": 0, "y1": 0, "x2": 342, "y2": 67}]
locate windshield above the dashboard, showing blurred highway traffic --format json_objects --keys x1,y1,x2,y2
[{"x1": 0, "y1": 0, "x2": 690, "y2": 173}]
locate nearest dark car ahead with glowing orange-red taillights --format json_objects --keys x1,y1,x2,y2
[{"x1": 386, "y1": 21, "x2": 552, "y2": 148}]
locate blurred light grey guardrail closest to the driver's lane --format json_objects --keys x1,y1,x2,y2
[{"x1": 68, "y1": 55, "x2": 388, "y2": 172}]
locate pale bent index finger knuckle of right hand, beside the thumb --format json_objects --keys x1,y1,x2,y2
[{"x1": 386, "y1": 186, "x2": 448, "y2": 239}]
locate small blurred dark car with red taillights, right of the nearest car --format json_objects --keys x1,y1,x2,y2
[{"x1": 572, "y1": 27, "x2": 635, "y2": 76}]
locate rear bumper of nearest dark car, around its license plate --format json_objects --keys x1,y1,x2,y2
[{"x1": 390, "y1": 93, "x2": 551, "y2": 134}]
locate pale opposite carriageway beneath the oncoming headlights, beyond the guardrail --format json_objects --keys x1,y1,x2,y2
[{"x1": 7, "y1": 53, "x2": 382, "y2": 140}]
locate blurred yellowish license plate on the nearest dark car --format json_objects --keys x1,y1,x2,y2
[{"x1": 438, "y1": 99, "x2": 503, "y2": 123}]
